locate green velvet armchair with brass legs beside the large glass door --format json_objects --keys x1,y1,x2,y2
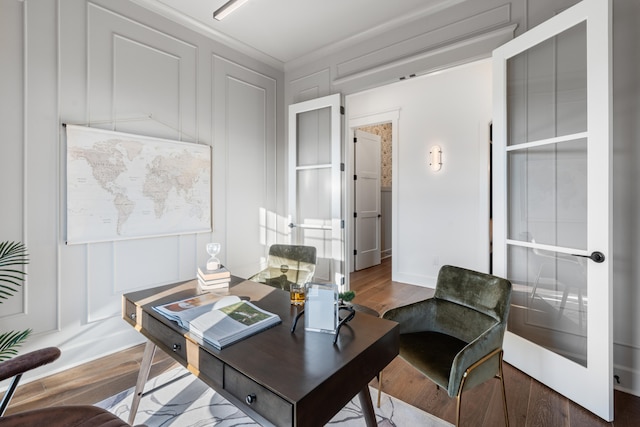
[{"x1": 378, "y1": 265, "x2": 511, "y2": 426}]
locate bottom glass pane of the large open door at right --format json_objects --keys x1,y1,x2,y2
[{"x1": 507, "y1": 245, "x2": 588, "y2": 366}]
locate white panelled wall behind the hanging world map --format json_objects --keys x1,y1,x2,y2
[{"x1": 0, "y1": 0, "x2": 284, "y2": 382}]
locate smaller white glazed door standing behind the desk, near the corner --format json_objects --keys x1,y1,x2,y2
[{"x1": 288, "y1": 94, "x2": 345, "y2": 285}]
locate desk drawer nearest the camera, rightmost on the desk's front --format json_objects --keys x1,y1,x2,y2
[{"x1": 224, "y1": 365, "x2": 293, "y2": 426}]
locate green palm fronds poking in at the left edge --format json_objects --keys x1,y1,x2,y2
[{"x1": 0, "y1": 242, "x2": 31, "y2": 361}]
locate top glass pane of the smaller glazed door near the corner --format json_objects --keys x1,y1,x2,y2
[{"x1": 296, "y1": 107, "x2": 331, "y2": 166}]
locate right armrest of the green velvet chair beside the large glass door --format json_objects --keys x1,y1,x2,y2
[{"x1": 448, "y1": 323, "x2": 505, "y2": 396}]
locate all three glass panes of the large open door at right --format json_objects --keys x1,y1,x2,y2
[{"x1": 507, "y1": 22, "x2": 588, "y2": 366}]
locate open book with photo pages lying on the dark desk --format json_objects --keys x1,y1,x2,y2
[{"x1": 153, "y1": 293, "x2": 281, "y2": 349}]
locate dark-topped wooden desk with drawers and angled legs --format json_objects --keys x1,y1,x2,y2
[{"x1": 122, "y1": 278, "x2": 399, "y2": 427}]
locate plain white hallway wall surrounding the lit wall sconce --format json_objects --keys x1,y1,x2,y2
[{"x1": 346, "y1": 60, "x2": 492, "y2": 287}]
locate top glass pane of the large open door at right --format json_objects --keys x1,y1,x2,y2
[{"x1": 507, "y1": 22, "x2": 587, "y2": 145}]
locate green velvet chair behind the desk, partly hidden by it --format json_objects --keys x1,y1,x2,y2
[{"x1": 249, "y1": 245, "x2": 316, "y2": 291}]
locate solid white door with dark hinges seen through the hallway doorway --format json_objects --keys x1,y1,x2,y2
[{"x1": 354, "y1": 130, "x2": 382, "y2": 270}]
